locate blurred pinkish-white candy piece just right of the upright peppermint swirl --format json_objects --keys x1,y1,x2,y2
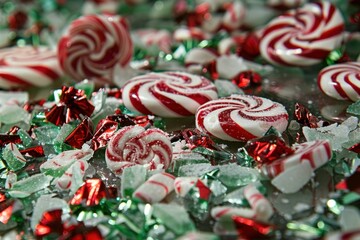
[{"x1": 134, "y1": 29, "x2": 172, "y2": 53}]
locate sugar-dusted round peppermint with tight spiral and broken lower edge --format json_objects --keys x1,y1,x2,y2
[{"x1": 105, "y1": 126, "x2": 172, "y2": 174}]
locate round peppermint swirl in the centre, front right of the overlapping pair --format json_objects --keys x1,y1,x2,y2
[{"x1": 196, "y1": 95, "x2": 288, "y2": 141}]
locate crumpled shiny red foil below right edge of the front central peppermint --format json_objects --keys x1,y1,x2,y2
[{"x1": 245, "y1": 135, "x2": 294, "y2": 165}]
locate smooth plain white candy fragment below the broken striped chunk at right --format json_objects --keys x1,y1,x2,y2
[{"x1": 271, "y1": 161, "x2": 313, "y2": 193}]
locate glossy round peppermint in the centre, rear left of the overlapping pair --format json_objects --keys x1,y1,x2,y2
[{"x1": 122, "y1": 72, "x2": 217, "y2": 117}]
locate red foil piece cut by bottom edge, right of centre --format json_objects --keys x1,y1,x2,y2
[{"x1": 232, "y1": 216, "x2": 273, "y2": 240}]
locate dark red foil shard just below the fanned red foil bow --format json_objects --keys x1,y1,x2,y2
[{"x1": 64, "y1": 118, "x2": 93, "y2": 149}]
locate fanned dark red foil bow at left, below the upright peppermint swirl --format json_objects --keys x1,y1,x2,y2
[{"x1": 45, "y1": 86, "x2": 95, "y2": 126}]
